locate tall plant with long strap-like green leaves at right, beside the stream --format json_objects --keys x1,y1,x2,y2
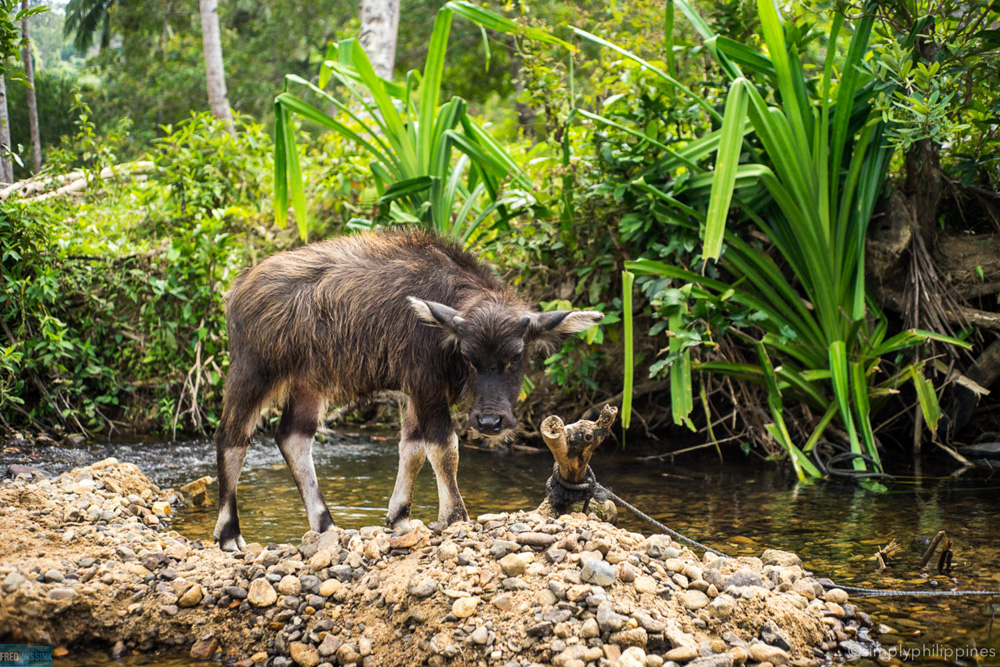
[{"x1": 612, "y1": 0, "x2": 961, "y2": 478}]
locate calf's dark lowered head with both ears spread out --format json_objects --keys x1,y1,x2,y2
[{"x1": 410, "y1": 296, "x2": 604, "y2": 436}]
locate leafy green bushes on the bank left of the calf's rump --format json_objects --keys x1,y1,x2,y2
[{"x1": 0, "y1": 109, "x2": 287, "y2": 431}]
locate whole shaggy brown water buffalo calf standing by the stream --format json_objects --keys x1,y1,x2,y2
[{"x1": 215, "y1": 231, "x2": 603, "y2": 550}]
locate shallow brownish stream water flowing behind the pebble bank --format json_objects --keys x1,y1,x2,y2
[{"x1": 13, "y1": 434, "x2": 1000, "y2": 667}]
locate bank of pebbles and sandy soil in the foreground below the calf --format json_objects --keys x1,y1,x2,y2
[{"x1": 0, "y1": 459, "x2": 869, "y2": 667}]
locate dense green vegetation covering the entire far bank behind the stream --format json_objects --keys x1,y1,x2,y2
[{"x1": 0, "y1": 0, "x2": 1000, "y2": 477}]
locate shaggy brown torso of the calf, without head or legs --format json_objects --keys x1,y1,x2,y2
[{"x1": 220, "y1": 231, "x2": 516, "y2": 403}]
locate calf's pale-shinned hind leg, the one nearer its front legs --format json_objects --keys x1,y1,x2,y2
[{"x1": 274, "y1": 385, "x2": 333, "y2": 533}]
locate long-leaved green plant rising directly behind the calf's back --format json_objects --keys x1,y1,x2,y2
[{"x1": 274, "y1": 2, "x2": 560, "y2": 243}]
